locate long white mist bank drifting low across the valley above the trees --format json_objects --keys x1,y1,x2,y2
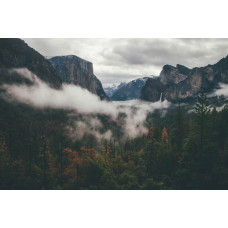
[{"x1": 3, "y1": 68, "x2": 170, "y2": 139}]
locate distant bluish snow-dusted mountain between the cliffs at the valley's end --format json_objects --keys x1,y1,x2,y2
[{"x1": 111, "y1": 77, "x2": 153, "y2": 101}]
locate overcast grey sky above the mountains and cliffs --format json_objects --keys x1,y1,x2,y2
[{"x1": 24, "y1": 38, "x2": 228, "y2": 85}]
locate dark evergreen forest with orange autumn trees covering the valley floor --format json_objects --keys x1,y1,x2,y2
[{"x1": 0, "y1": 93, "x2": 228, "y2": 189}]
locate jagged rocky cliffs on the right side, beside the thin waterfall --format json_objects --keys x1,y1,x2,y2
[{"x1": 141, "y1": 56, "x2": 228, "y2": 101}]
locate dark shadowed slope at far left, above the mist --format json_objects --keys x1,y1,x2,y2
[{"x1": 0, "y1": 39, "x2": 62, "y2": 88}]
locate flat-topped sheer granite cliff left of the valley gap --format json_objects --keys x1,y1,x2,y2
[{"x1": 49, "y1": 55, "x2": 107, "y2": 99}]
